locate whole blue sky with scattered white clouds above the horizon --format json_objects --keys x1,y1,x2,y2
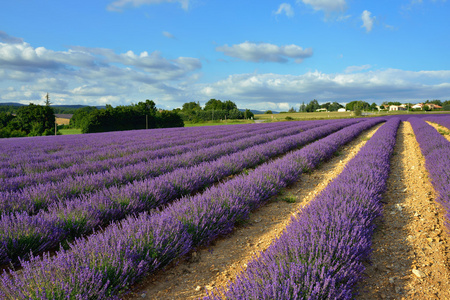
[{"x1": 0, "y1": 0, "x2": 450, "y2": 110}]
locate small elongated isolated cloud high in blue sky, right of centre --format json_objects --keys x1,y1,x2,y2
[{"x1": 216, "y1": 42, "x2": 313, "y2": 63}]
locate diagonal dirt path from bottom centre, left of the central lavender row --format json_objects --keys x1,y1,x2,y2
[{"x1": 123, "y1": 125, "x2": 381, "y2": 300}]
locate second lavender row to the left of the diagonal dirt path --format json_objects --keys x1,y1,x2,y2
[{"x1": 0, "y1": 120, "x2": 357, "y2": 263}]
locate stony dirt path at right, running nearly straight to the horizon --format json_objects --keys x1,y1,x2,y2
[{"x1": 356, "y1": 122, "x2": 450, "y2": 300}]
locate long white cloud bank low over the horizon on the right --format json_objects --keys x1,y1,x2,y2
[{"x1": 198, "y1": 69, "x2": 450, "y2": 110}]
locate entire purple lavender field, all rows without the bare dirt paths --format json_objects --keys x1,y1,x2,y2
[{"x1": 0, "y1": 116, "x2": 450, "y2": 299}]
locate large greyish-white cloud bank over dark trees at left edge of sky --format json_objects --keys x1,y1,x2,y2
[{"x1": 0, "y1": 31, "x2": 202, "y2": 104}]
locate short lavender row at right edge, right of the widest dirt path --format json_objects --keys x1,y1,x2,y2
[{"x1": 408, "y1": 118, "x2": 450, "y2": 228}]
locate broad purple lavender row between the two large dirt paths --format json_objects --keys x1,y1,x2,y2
[{"x1": 205, "y1": 119, "x2": 399, "y2": 299}]
